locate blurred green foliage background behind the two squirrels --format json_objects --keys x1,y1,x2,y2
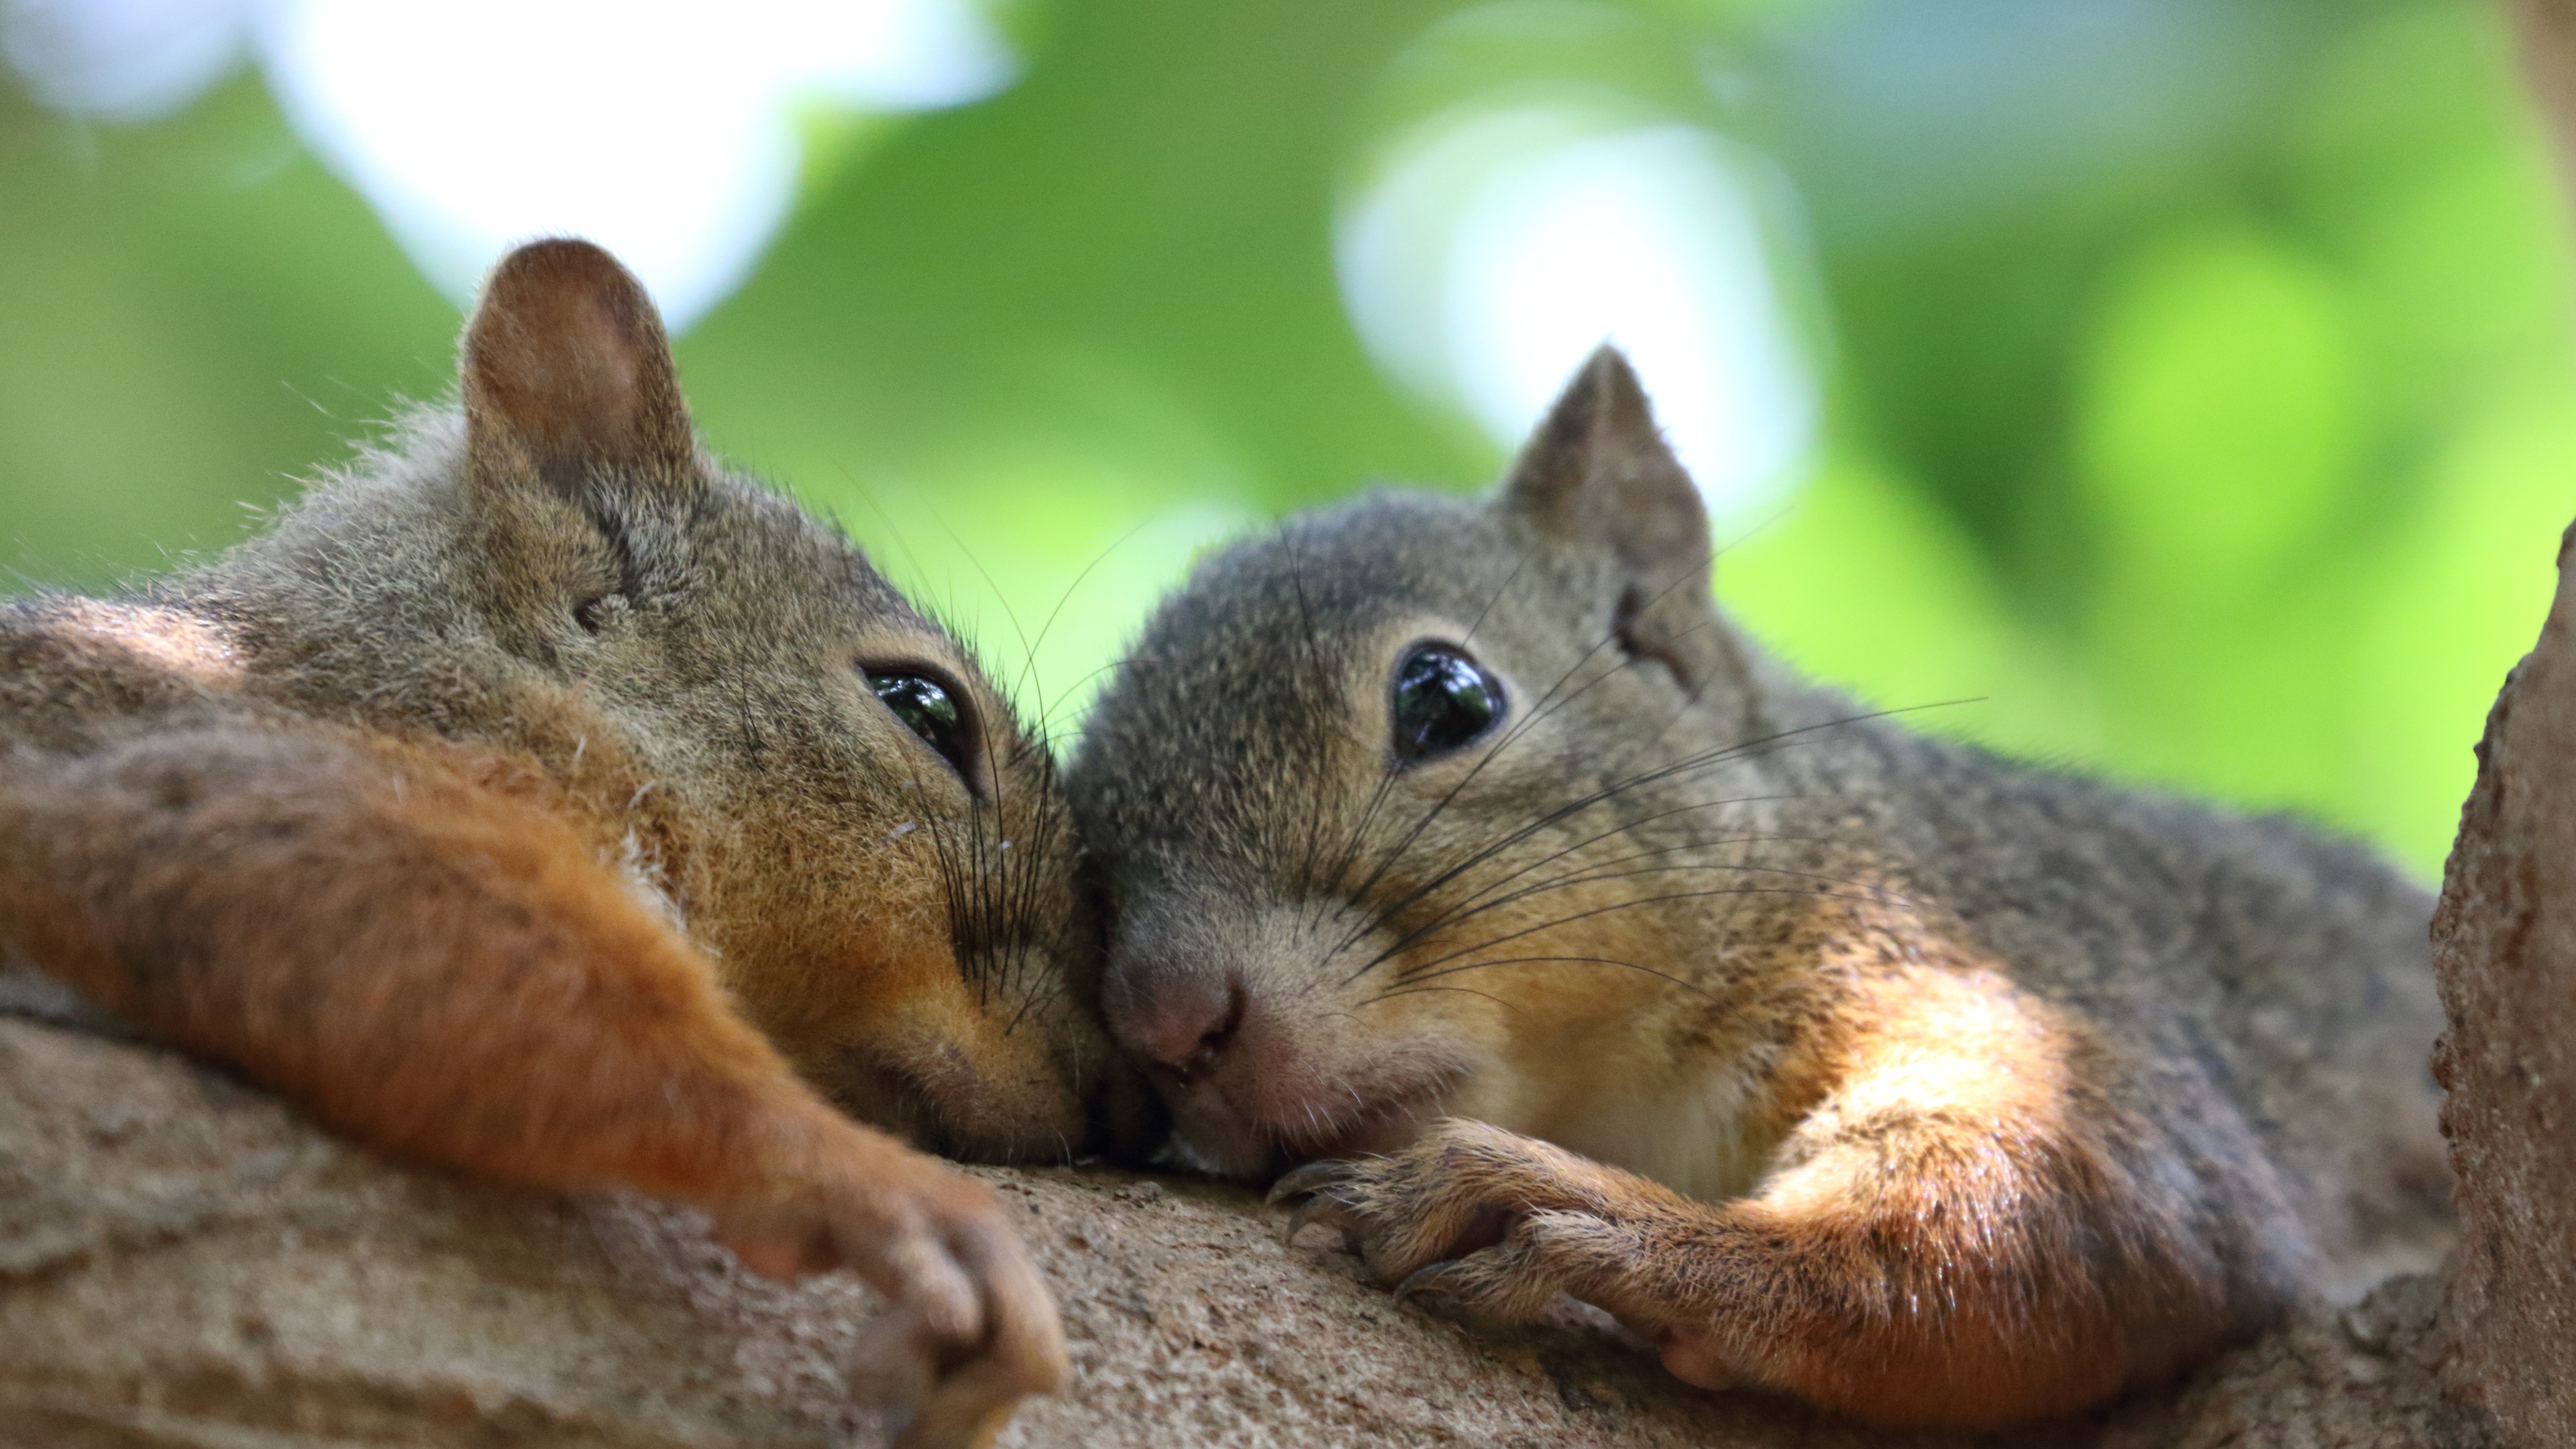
[{"x1": 0, "y1": 0, "x2": 2576, "y2": 877}]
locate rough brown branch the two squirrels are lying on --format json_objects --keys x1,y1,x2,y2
[{"x1": 0, "y1": 1016, "x2": 2486, "y2": 1449}]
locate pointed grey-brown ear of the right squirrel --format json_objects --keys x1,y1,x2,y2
[{"x1": 1497, "y1": 345, "x2": 1723, "y2": 691}]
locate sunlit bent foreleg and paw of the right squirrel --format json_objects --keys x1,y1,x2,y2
[{"x1": 1275, "y1": 969, "x2": 2277, "y2": 1426}]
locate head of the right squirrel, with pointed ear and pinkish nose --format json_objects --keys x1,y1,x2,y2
[{"x1": 1069, "y1": 348, "x2": 1792, "y2": 1176}]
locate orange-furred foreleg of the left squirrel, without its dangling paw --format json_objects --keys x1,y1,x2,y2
[{"x1": 0, "y1": 730, "x2": 816, "y2": 1207}]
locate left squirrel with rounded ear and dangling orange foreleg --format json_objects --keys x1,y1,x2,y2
[{"x1": 0, "y1": 239, "x2": 1149, "y2": 1444}]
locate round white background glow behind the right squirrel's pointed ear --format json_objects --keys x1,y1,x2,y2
[{"x1": 1337, "y1": 106, "x2": 1819, "y2": 513}]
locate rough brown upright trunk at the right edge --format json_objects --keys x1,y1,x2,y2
[{"x1": 2434, "y1": 521, "x2": 2576, "y2": 1449}]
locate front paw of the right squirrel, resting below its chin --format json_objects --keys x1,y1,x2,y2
[{"x1": 1270, "y1": 1119, "x2": 1620, "y2": 1323}]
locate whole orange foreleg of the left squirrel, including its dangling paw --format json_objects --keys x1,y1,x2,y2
[{"x1": 0, "y1": 730, "x2": 1064, "y2": 1444}]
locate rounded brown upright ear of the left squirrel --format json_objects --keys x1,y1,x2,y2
[{"x1": 464, "y1": 239, "x2": 696, "y2": 492}]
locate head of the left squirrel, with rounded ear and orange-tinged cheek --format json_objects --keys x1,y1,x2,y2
[{"x1": 337, "y1": 239, "x2": 1146, "y2": 1161}]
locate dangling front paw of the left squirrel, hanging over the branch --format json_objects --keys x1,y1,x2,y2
[{"x1": 716, "y1": 1127, "x2": 1067, "y2": 1449}]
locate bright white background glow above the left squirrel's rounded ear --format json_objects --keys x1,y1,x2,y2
[{"x1": 0, "y1": 0, "x2": 1018, "y2": 327}]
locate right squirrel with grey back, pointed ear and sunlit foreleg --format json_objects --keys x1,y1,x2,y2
[{"x1": 1067, "y1": 348, "x2": 2450, "y2": 1428}]
